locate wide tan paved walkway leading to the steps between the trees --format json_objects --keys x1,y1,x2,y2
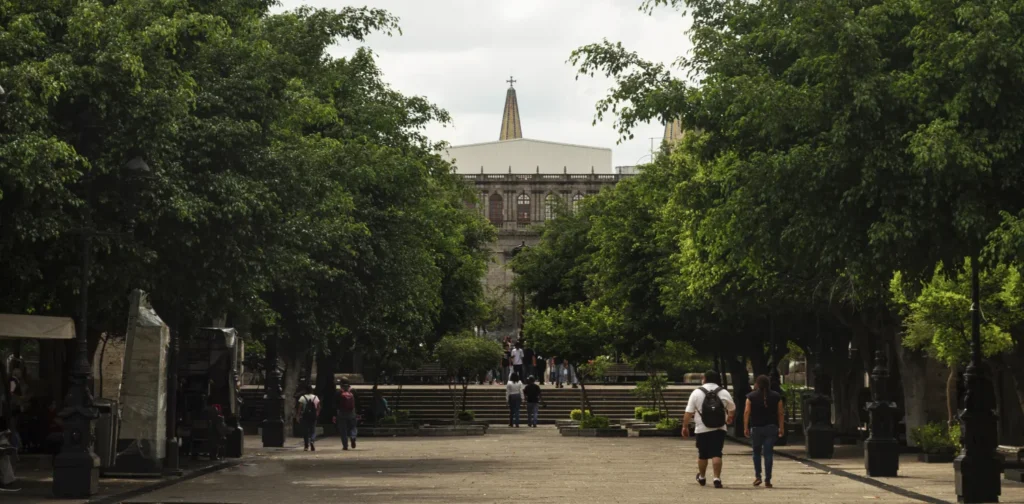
[{"x1": 116, "y1": 426, "x2": 1024, "y2": 504}]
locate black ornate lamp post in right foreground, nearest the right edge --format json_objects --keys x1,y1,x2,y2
[{"x1": 953, "y1": 257, "x2": 1002, "y2": 502}]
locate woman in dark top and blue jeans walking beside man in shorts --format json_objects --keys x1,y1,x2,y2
[{"x1": 743, "y1": 375, "x2": 785, "y2": 489}]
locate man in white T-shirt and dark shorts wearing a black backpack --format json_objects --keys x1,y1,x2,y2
[{"x1": 683, "y1": 371, "x2": 736, "y2": 489}]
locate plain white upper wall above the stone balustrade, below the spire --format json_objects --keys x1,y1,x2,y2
[{"x1": 444, "y1": 138, "x2": 612, "y2": 175}]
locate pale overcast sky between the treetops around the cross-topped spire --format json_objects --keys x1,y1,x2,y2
[{"x1": 282, "y1": 0, "x2": 690, "y2": 166}]
